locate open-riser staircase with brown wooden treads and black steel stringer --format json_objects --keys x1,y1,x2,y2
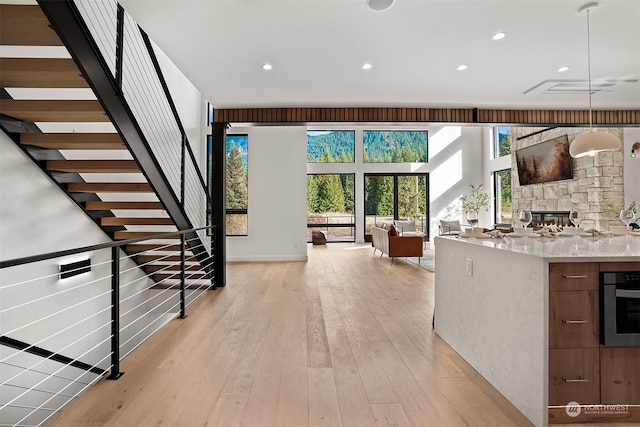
[{"x1": 0, "y1": 1, "x2": 210, "y2": 287}]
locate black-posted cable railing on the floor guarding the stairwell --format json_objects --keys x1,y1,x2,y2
[{"x1": 0, "y1": 227, "x2": 215, "y2": 426}]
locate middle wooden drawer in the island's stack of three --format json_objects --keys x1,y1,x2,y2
[{"x1": 549, "y1": 291, "x2": 600, "y2": 348}]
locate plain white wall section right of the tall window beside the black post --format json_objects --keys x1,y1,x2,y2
[{"x1": 227, "y1": 126, "x2": 307, "y2": 261}]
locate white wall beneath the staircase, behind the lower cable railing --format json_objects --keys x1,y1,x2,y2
[{"x1": 0, "y1": 132, "x2": 160, "y2": 366}]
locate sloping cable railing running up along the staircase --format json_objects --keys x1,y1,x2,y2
[{"x1": 54, "y1": 0, "x2": 211, "y2": 254}]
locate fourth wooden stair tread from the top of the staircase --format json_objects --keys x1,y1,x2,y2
[{"x1": 20, "y1": 133, "x2": 127, "y2": 150}]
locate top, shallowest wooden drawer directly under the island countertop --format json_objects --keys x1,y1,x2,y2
[{"x1": 549, "y1": 262, "x2": 600, "y2": 291}]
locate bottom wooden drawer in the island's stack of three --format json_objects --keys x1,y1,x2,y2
[{"x1": 549, "y1": 348, "x2": 600, "y2": 406}]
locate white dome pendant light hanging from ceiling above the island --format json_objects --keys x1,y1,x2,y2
[{"x1": 569, "y1": 2, "x2": 622, "y2": 158}]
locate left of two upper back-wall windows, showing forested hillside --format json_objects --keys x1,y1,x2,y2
[{"x1": 307, "y1": 130, "x2": 355, "y2": 163}]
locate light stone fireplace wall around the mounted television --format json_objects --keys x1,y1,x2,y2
[{"x1": 511, "y1": 127, "x2": 624, "y2": 230}]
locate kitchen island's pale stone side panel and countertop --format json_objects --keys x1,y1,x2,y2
[{"x1": 435, "y1": 236, "x2": 640, "y2": 426}]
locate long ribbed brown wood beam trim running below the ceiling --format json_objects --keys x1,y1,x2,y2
[{"x1": 214, "y1": 108, "x2": 640, "y2": 126}]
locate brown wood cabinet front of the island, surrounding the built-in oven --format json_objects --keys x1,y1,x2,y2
[{"x1": 549, "y1": 262, "x2": 640, "y2": 423}]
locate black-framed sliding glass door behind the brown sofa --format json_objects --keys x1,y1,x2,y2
[{"x1": 364, "y1": 174, "x2": 429, "y2": 241}]
